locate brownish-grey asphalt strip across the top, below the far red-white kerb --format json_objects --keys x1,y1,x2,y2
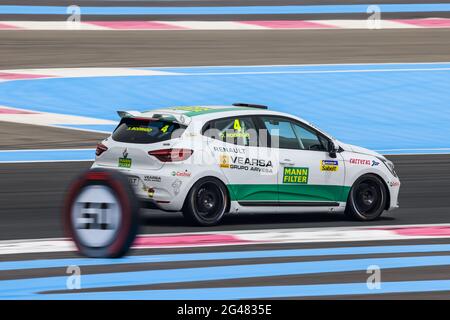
[{"x1": 0, "y1": 29, "x2": 450, "y2": 69}]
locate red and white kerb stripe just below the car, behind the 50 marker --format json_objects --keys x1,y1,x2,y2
[{"x1": 0, "y1": 224, "x2": 450, "y2": 255}]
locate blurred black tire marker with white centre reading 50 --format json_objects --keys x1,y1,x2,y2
[{"x1": 63, "y1": 169, "x2": 140, "y2": 258}]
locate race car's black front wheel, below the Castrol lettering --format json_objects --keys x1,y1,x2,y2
[{"x1": 345, "y1": 174, "x2": 388, "y2": 221}]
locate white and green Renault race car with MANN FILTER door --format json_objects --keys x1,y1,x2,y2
[{"x1": 93, "y1": 103, "x2": 400, "y2": 226}]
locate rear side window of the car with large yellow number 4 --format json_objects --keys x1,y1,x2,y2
[{"x1": 204, "y1": 117, "x2": 258, "y2": 146}]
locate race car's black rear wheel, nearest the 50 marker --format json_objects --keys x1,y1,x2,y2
[{"x1": 183, "y1": 177, "x2": 228, "y2": 226}]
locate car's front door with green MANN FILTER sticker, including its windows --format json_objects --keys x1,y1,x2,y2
[{"x1": 261, "y1": 116, "x2": 346, "y2": 207}]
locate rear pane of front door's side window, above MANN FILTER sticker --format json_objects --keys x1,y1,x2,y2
[{"x1": 261, "y1": 117, "x2": 303, "y2": 150}]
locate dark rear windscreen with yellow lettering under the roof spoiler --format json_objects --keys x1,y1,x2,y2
[{"x1": 112, "y1": 118, "x2": 186, "y2": 143}]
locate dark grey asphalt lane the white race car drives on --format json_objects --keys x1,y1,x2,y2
[{"x1": 0, "y1": 155, "x2": 450, "y2": 240}]
